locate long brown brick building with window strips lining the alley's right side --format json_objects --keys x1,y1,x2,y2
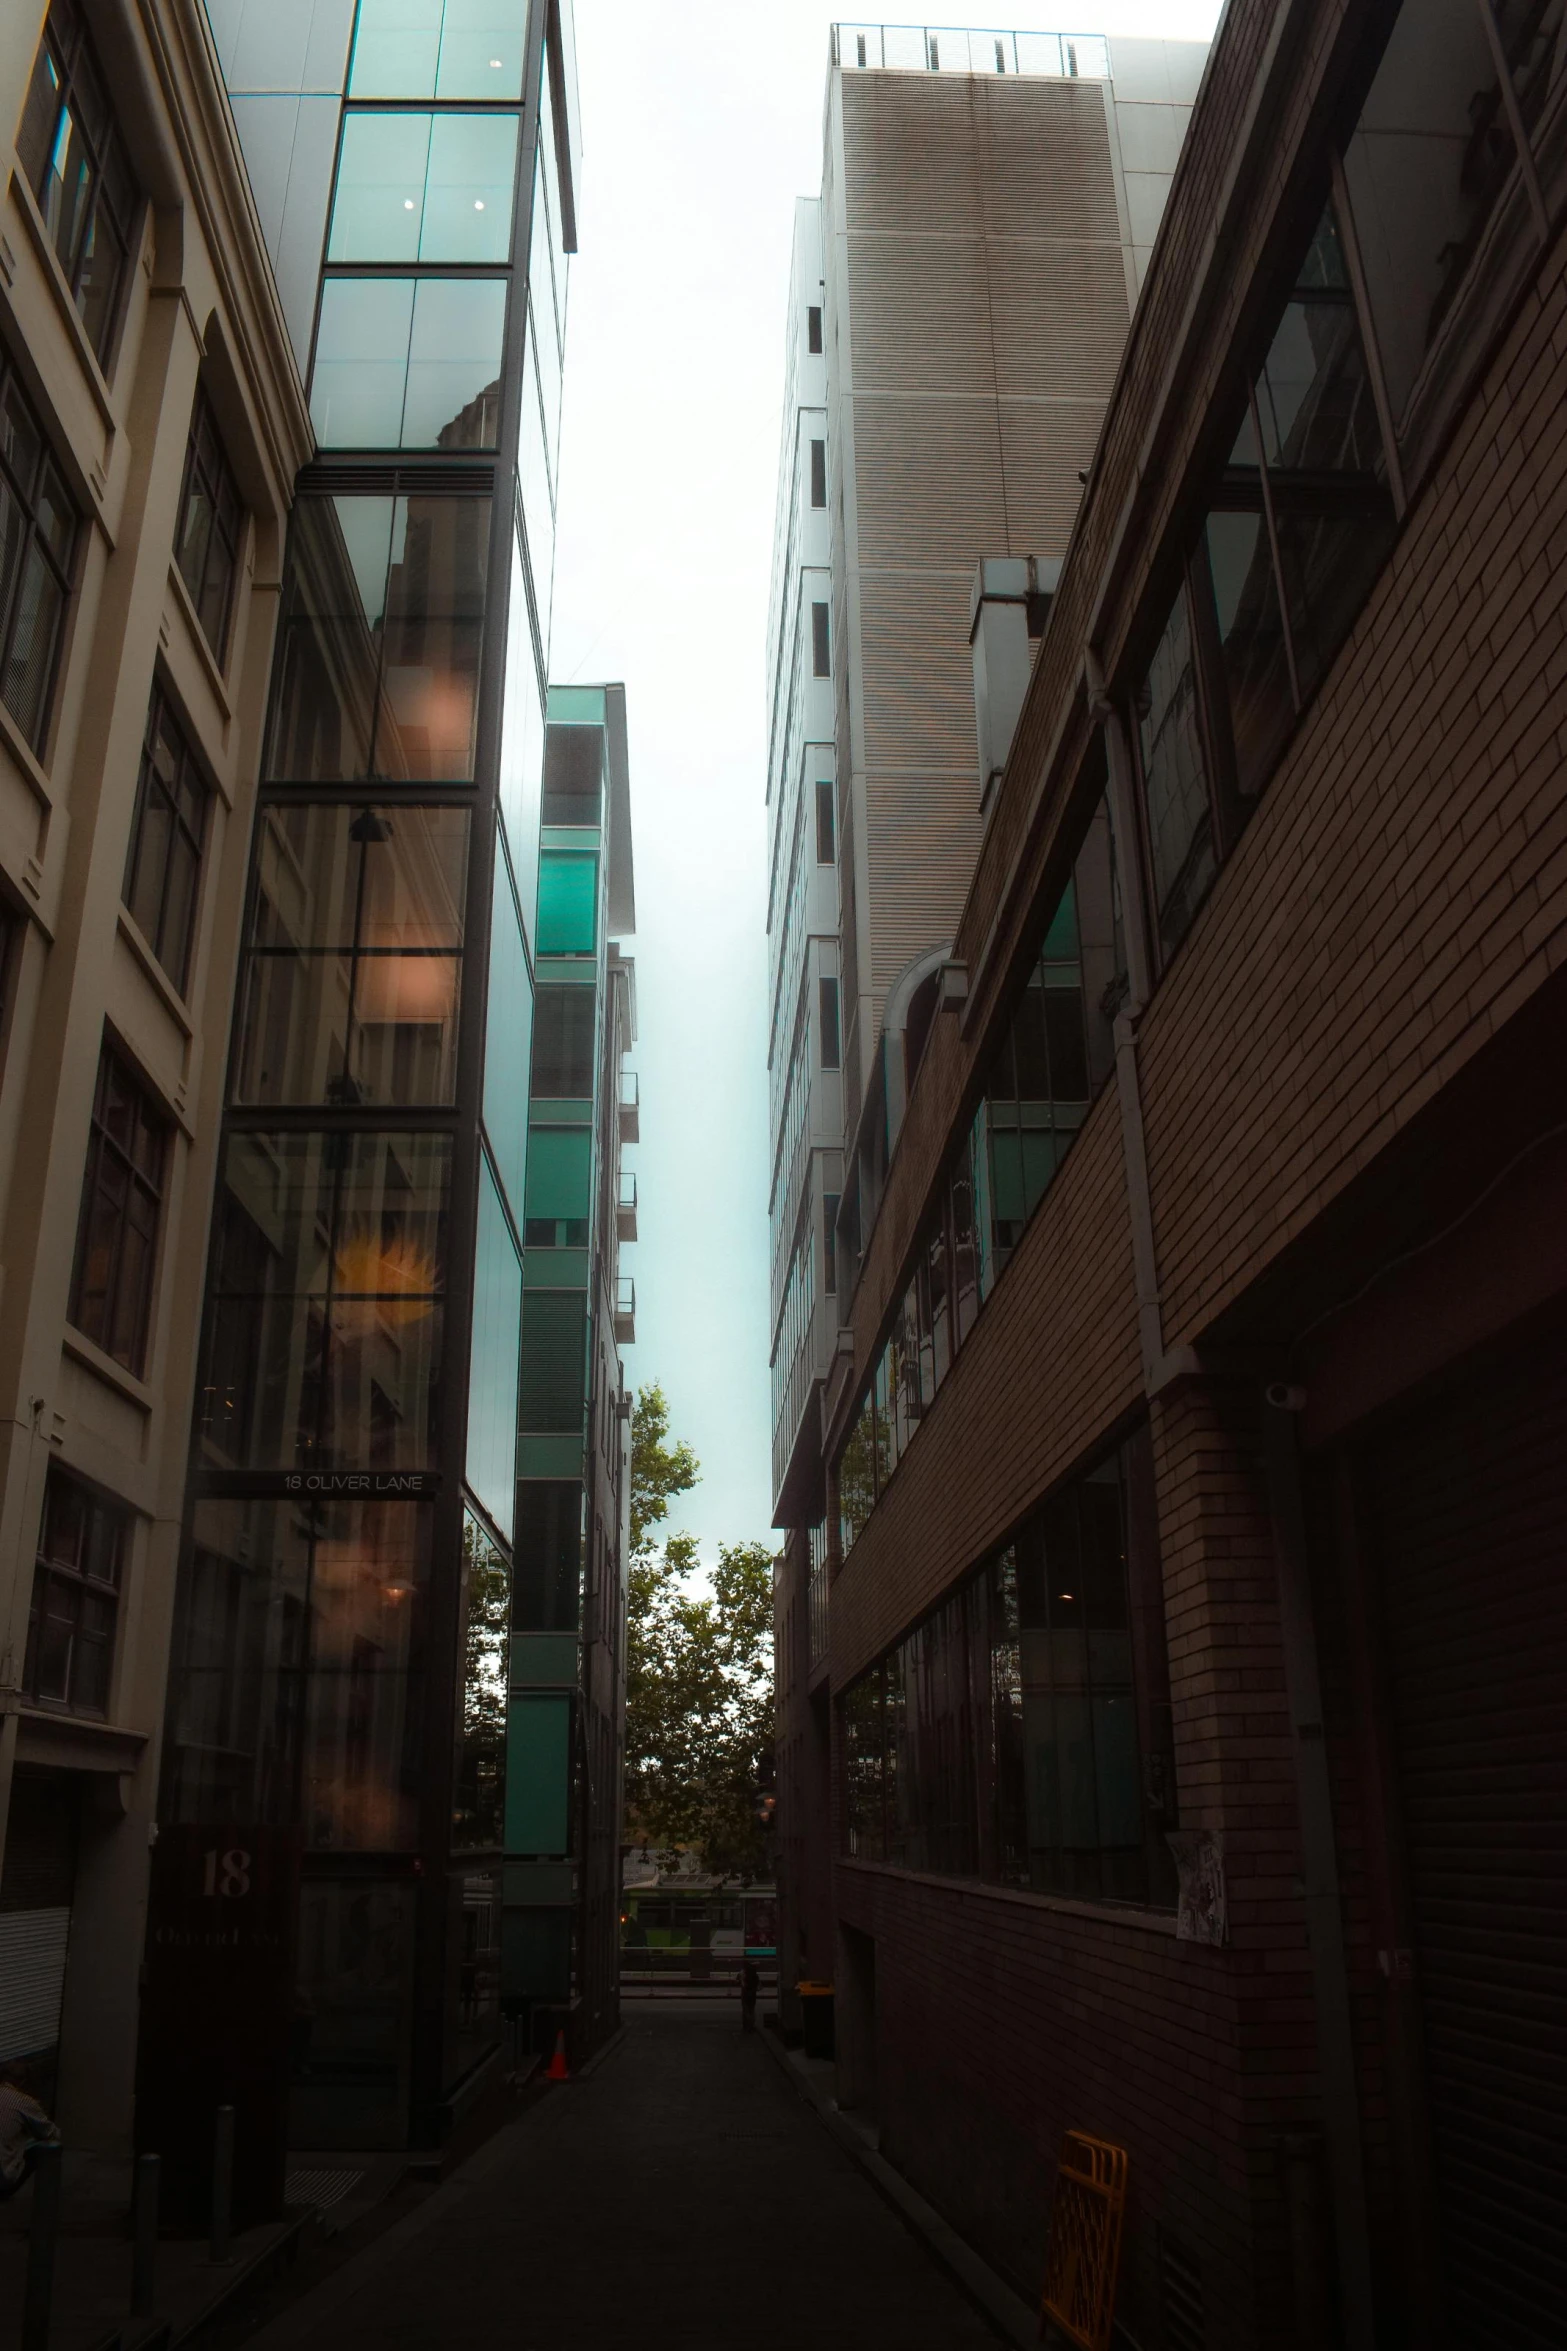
[{"x1": 778, "y1": 0, "x2": 1567, "y2": 2351}]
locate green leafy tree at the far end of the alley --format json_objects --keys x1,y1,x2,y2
[{"x1": 625, "y1": 1387, "x2": 773, "y2": 1878}]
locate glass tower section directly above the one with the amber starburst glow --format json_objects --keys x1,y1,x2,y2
[{"x1": 233, "y1": 804, "x2": 468, "y2": 1105}]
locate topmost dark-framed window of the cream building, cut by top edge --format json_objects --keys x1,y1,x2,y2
[{"x1": 16, "y1": 0, "x2": 143, "y2": 374}]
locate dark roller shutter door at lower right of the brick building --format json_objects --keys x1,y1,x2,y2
[{"x1": 1367, "y1": 1333, "x2": 1567, "y2": 2351}]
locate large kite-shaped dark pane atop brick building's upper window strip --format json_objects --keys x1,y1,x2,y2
[{"x1": 1344, "y1": 0, "x2": 1513, "y2": 418}]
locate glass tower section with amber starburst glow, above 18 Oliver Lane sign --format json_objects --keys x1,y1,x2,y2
[{"x1": 197, "y1": 1133, "x2": 451, "y2": 1469}]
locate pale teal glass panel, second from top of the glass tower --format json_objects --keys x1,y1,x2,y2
[{"x1": 327, "y1": 108, "x2": 517, "y2": 261}]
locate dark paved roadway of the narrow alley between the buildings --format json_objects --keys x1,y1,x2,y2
[{"x1": 251, "y1": 2003, "x2": 998, "y2": 2351}]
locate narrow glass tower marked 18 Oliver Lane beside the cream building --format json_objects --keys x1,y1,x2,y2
[{"x1": 145, "y1": 0, "x2": 601, "y2": 2146}]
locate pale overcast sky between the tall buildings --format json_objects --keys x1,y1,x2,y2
[{"x1": 552, "y1": 0, "x2": 1219, "y2": 1556}]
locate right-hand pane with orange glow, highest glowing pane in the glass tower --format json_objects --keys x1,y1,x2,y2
[{"x1": 374, "y1": 498, "x2": 491, "y2": 783}]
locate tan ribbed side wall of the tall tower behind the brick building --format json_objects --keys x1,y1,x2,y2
[{"x1": 834, "y1": 73, "x2": 1128, "y2": 1043}]
